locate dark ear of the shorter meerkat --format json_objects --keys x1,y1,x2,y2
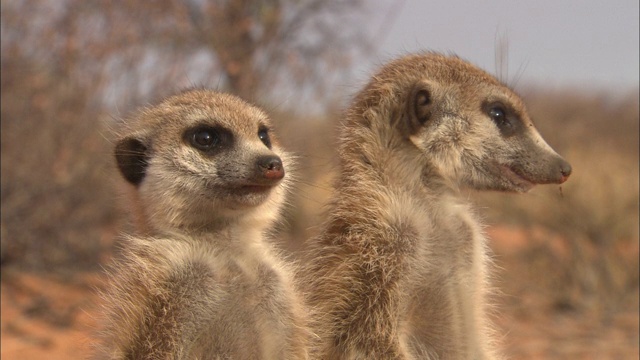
[{"x1": 115, "y1": 137, "x2": 149, "y2": 186}]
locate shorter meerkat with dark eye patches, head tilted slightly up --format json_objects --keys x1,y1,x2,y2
[{"x1": 97, "y1": 89, "x2": 307, "y2": 359}]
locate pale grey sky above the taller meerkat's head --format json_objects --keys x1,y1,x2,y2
[{"x1": 367, "y1": 0, "x2": 640, "y2": 92}]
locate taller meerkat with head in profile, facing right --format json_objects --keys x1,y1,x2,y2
[{"x1": 305, "y1": 53, "x2": 571, "y2": 359}]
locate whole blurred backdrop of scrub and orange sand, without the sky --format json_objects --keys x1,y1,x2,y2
[{"x1": 0, "y1": 0, "x2": 640, "y2": 359}]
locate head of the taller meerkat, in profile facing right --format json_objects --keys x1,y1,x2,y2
[{"x1": 393, "y1": 54, "x2": 571, "y2": 192}]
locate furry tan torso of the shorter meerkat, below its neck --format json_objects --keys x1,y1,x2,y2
[{"x1": 104, "y1": 231, "x2": 303, "y2": 359}]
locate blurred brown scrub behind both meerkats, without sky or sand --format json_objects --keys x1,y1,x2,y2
[{"x1": 0, "y1": 0, "x2": 639, "y2": 328}]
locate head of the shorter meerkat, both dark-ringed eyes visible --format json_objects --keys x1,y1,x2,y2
[{"x1": 115, "y1": 90, "x2": 285, "y2": 232}]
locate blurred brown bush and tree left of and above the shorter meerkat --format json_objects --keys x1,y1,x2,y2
[{"x1": 0, "y1": 0, "x2": 369, "y2": 271}]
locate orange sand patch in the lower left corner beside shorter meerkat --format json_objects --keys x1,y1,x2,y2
[{"x1": 0, "y1": 270, "x2": 102, "y2": 360}]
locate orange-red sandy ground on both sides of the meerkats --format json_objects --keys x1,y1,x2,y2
[{"x1": 1, "y1": 229, "x2": 640, "y2": 360}]
